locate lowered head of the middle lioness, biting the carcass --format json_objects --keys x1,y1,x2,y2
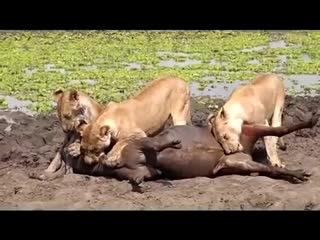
[{"x1": 77, "y1": 120, "x2": 111, "y2": 164}]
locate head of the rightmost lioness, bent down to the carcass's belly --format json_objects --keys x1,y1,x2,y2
[{"x1": 207, "y1": 108, "x2": 243, "y2": 154}]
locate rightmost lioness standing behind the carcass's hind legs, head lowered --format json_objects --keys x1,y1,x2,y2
[{"x1": 213, "y1": 74, "x2": 285, "y2": 167}]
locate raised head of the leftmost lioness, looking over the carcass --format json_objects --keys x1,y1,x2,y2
[{"x1": 53, "y1": 89, "x2": 86, "y2": 132}]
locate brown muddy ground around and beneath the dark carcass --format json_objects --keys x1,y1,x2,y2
[{"x1": 0, "y1": 96, "x2": 320, "y2": 210}]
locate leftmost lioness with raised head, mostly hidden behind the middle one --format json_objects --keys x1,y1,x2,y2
[{"x1": 45, "y1": 89, "x2": 103, "y2": 173}]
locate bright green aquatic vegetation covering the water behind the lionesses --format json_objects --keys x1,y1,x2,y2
[{"x1": 0, "y1": 31, "x2": 320, "y2": 113}]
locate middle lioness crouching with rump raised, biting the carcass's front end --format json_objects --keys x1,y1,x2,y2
[{"x1": 78, "y1": 76, "x2": 191, "y2": 167}]
